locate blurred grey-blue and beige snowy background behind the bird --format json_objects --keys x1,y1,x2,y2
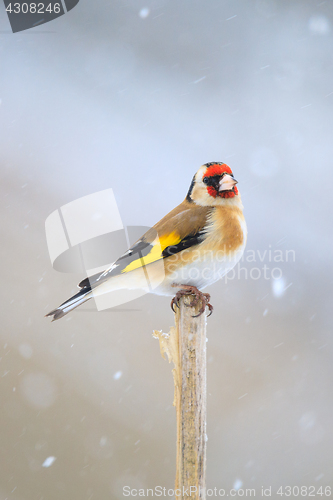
[{"x1": 0, "y1": 0, "x2": 333, "y2": 500}]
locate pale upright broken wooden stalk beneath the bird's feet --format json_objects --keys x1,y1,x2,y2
[{"x1": 154, "y1": 295, "x2": 207, "y2": 500}]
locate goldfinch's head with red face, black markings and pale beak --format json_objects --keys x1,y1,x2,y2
[{"x1": 186, "y1": 162, "x2": 240, "y2": 206}]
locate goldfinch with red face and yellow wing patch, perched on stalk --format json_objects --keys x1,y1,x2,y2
[{"x1": 46, "y1": 162, "x2": 247, "y2": 321}]
